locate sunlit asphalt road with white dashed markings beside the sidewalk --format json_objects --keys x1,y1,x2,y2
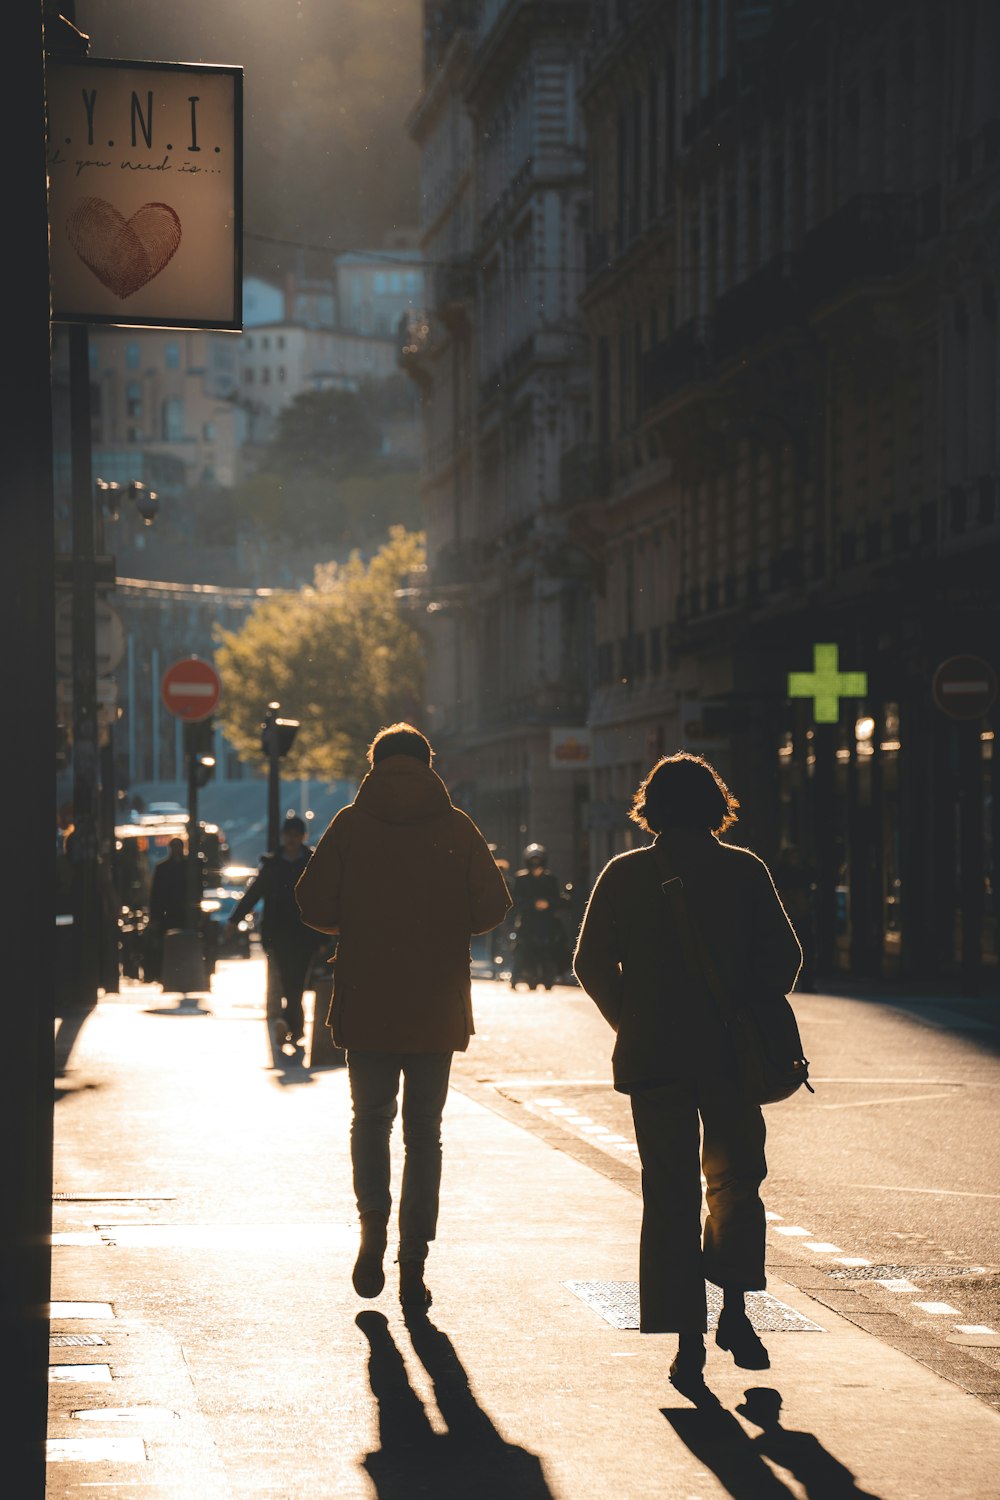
[{"x1": 454, "y1": 981, "x2": 1000, "y2": 1404}]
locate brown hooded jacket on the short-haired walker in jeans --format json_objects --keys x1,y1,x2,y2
[{"x1": 295, "y1": 755, "x2": 510, "y2": 1052}]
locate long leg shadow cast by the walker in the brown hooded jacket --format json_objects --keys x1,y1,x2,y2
[{"x1": 355, "y1": 1311, "x2": 553, "y2": 1500}]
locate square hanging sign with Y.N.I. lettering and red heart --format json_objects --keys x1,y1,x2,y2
[{"x1": 46, "y1": 57, "x2": 243, "y2": 333}]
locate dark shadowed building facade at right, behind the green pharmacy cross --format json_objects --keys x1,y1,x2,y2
[{"x1": 577, "y1": 0, "x2": 1000, "y2": 980}]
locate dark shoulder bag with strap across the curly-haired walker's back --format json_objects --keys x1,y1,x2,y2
[{"x1": 651, "y1": 849, "x2": 816, "y2": 1104}]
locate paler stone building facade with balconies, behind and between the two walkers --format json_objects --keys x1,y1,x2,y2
[{"x1": 406, "y1": 0, "x2": 589, "y2": 884}]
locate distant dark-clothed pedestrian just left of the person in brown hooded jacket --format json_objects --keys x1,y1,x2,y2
[{"x1": 226, "y1": 818, "x2": 319, "y2": 1047}]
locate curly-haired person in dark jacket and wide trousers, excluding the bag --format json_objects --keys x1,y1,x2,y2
[{"x1": 574, "y1": 752, "x2": 802, "y2": 1391}]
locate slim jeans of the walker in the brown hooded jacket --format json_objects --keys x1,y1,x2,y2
[{"x1": 348, "y1": 1047, "x2": 451, "y2": 1262}]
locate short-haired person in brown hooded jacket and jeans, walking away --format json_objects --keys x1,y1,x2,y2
[{"x1": 295, "y1": 723, "x2": 511, "y2": 1310}]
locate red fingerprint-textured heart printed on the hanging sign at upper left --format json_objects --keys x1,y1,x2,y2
[{"x1": 66, "y1": 198, "x2": 180, "y2": 302}]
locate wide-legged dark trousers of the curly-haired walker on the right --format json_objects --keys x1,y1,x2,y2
[{"x1": 631, "y1": 1080, "x2": 768, "y2": 1334}]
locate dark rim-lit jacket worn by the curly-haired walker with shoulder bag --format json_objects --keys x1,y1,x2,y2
[{"x1": 573, "y1": 830, "x2": 802, "y2": 1094}]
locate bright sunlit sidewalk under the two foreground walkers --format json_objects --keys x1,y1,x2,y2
[{"x1": 46, "y1": 965, "x2": 1000, "y2": 1500}]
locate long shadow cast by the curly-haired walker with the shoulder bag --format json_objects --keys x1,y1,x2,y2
[{"x1": 663, "y1": 1386, "x2": 879, "y2": 1500}]
